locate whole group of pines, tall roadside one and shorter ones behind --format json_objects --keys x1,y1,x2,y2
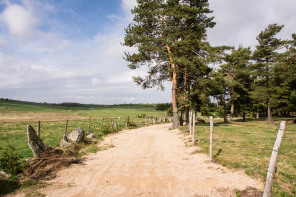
[{"x1": 123, "y1": 0, "x2": 296, "y2": 128}]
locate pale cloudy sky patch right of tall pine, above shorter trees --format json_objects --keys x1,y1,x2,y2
[{"x1": 208, "y1": 0, "x2": 296, "y2": 48}]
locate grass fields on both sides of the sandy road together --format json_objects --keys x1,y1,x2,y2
[{"x1": 0, "y1": 100, "x2": 296, "y2": 196}]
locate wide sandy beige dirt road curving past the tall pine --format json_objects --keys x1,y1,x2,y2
[{"x1": 39, "y1": 124, "x2": 263, "y2": 197}]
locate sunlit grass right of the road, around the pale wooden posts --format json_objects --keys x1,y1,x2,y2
[{"x1": 181, "y1": 118, "x2": 296, "y2": 196}]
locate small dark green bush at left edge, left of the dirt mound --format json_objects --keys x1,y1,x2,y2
[{"x1": 0, "y1": 145, "x2": 25, "y2": 175}]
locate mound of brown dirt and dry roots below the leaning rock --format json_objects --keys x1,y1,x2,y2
[{"x1": 24, "y1": 149, "x2": 79, "y2": 179}]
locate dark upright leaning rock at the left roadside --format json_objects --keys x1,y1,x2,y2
[{"x1": 27, "y1": 125, "x2": 47, "y2": 157}]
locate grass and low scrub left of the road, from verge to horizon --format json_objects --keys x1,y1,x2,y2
[{"x1": 0, "y1": 99, "x2": 166, "y2": 196}]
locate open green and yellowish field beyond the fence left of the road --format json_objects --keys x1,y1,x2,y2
[{"x1": 0, "y1": 100, "x2": 166, "y2": 158}]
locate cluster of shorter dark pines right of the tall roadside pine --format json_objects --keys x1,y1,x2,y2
[{"x1": 212, "y1": 24, "x2": 296, "y2": 123}]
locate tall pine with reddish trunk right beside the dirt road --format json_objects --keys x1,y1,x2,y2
[{"x1": 123, "y1": 0, "x2": 215, "y2": 128}]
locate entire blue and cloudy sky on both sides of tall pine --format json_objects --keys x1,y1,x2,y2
[{"x1": 0, "y1": 0, "x2": 296, "y2": 104}]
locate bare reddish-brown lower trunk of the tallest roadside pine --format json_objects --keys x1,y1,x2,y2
[{"x1": 172, "y1": 68, "x2": 180, "y2": 129}]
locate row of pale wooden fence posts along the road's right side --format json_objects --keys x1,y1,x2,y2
[{"x1": 189, "y1": 111, "x2": 286, "y2": 197}]
